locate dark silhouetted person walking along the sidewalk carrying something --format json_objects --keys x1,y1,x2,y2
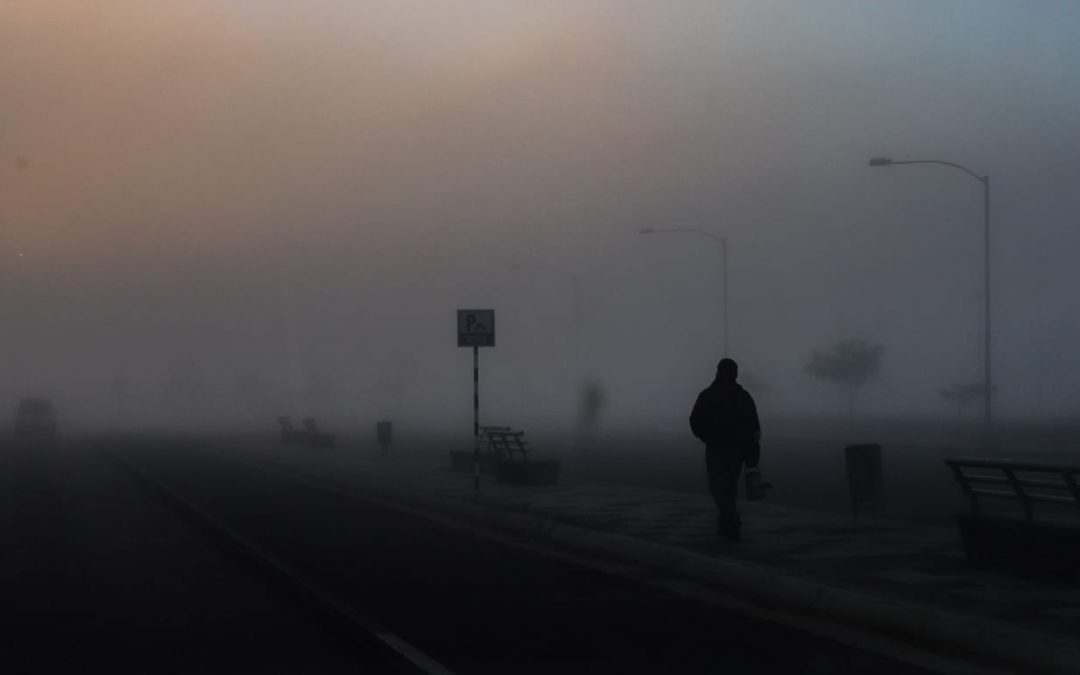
[{"x1": 690, "y1": 359, "x2": 761, "y2": 541}]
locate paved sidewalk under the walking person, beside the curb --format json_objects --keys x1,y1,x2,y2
[{"x1": 214, "y1": 443, "x2": 1080, "y2": 663}]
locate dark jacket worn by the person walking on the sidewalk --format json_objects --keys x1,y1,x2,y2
[{"x1": 690, "y1": 379, "x2": 761, "y2": 467}]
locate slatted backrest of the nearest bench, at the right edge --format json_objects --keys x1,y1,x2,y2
[{"x1": 945, "y1": 459, "x2": 1080, "y2": 521}]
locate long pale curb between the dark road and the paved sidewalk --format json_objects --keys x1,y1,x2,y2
[{"x1": 343, "y1": 476, "x2": 1080, "y2": 675}]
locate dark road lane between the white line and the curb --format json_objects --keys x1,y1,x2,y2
[{"x1": 103, "y1": 436, "x2": 937, "y2": 674}]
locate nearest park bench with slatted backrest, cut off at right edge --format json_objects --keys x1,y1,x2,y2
[{"x1": 945, "y1": 459, "x2": 1080, "y2": 579}]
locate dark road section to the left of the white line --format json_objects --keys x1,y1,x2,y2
[{"x1": 0, "y1": 444, "x2": 395, "y2": 673}]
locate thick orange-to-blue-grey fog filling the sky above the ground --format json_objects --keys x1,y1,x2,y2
[{"x1": 0, "y1": 0, "x2": 1080, "y2": 430}]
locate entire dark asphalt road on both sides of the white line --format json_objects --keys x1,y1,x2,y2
[{"x1": 0, "y1": 442, "x2": 941, "y2": 675}]
